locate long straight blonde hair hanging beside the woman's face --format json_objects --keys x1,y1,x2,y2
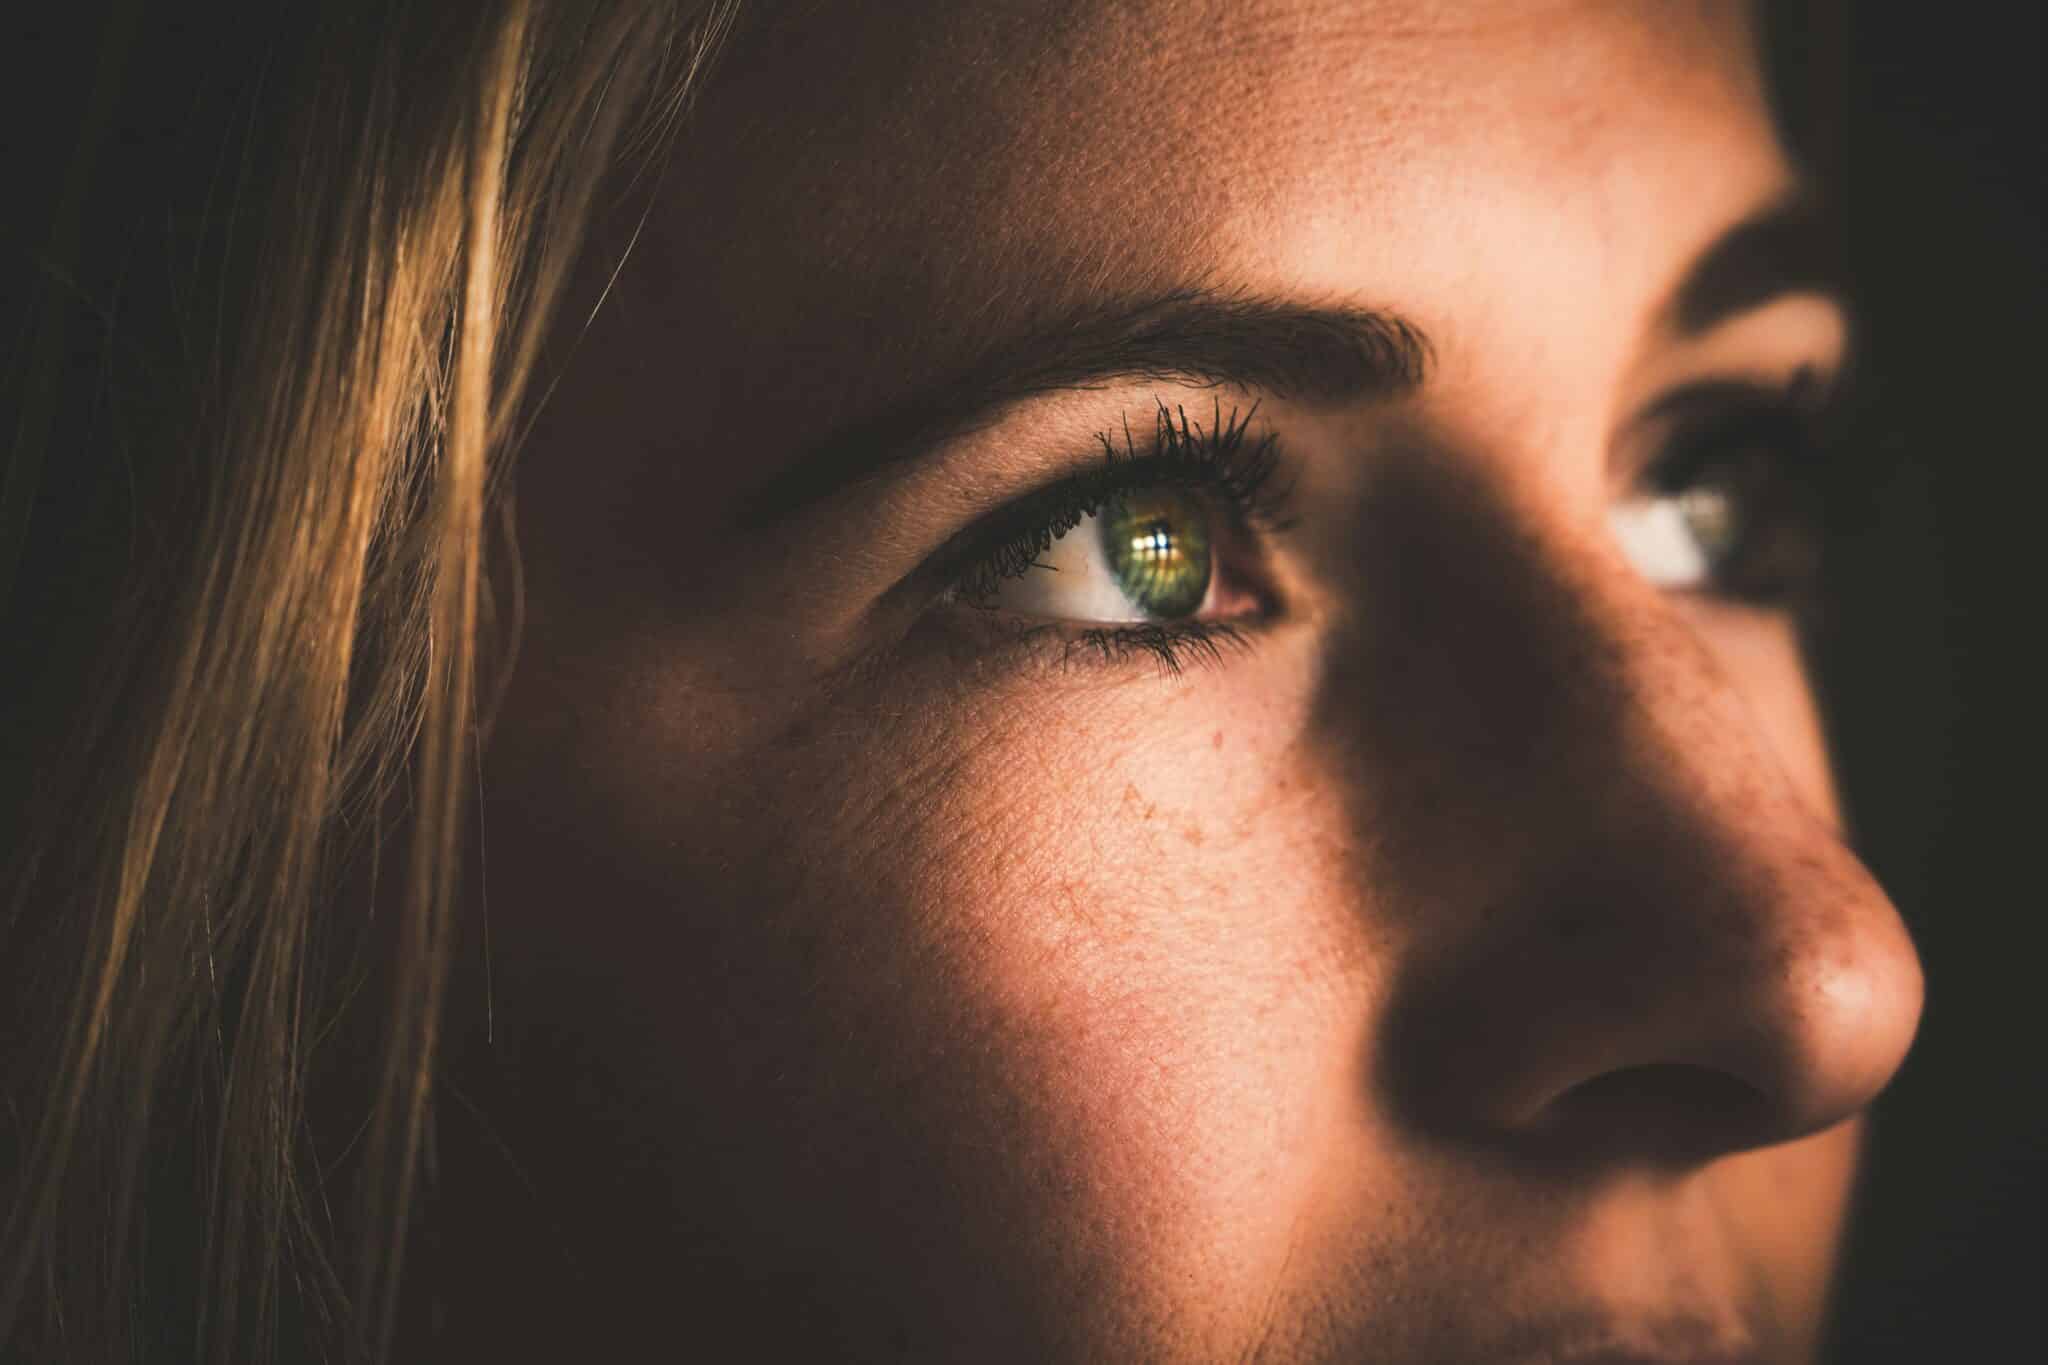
[{"x1": 0, "y1": 0, "x2": 733, "y2": 1361}]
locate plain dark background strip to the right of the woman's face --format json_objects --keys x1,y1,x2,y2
[{"x1": 1780, "y1": 0, "x2": 2048, "y2": 1363}]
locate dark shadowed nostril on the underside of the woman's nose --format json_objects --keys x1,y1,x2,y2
[{"x1": 1532, "y1": 1062, "x2": 1772, "y2": 1164}]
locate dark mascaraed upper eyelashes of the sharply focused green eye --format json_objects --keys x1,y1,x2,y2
[{"x1": 952, "y1": 399, "x2": 1292, "y2": 604}]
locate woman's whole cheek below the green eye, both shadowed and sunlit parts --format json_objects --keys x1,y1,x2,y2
[{"x1": 494, "y1": 634, "x2": 1364, "y2": 1351}]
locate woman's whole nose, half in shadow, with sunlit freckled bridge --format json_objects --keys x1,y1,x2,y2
[{"x1": 1368, "y1": 470, "x2": 1923, "y2": 1162}]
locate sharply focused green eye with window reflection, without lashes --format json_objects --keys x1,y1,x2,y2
[{"x1": 977, "y1": 489, "x2": 1233, "y2": 624}]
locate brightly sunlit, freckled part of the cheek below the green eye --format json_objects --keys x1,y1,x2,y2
[{"x1": 761, "y1": 675, "x2": 1362, "y2": 1349}]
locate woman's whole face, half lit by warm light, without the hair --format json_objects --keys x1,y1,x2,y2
[{"x1": 457, "y1": 0, "x2": 1921, "y2": 1363}]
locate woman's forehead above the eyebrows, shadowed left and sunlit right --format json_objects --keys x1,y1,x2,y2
[{"x1": 618, "y1": 0, "x2": 1786, "y2": 444}]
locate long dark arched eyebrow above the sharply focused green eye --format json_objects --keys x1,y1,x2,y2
[{"x1": 739, "y1": 289, "x2": 1432, "y2": 528}]
